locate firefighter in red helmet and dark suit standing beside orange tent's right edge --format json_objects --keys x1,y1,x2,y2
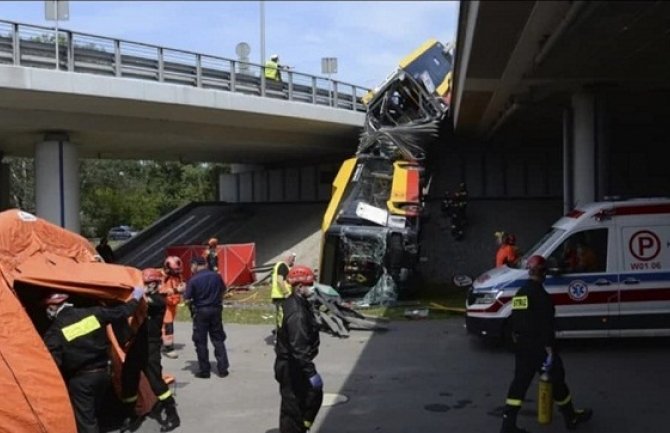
[{"x1": 121, "y1": 268, "x2": 180, "y2": 432}]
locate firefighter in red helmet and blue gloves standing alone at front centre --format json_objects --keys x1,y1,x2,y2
[{"x1": 275, "y1": 265, "x2": 323, "y2": 433}]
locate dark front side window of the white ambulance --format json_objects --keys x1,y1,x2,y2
[{"x1": 552, "y1": 228, "x2": 607, "y2": 273}]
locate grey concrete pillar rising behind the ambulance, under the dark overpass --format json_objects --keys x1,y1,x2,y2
[{"x1": 564, "y1": 92, "x2": 609, "y2": 208}]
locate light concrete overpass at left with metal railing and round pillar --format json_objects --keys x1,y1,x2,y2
[{"x1": 0, "y1": 21, "x2": 367, "y2": 231}]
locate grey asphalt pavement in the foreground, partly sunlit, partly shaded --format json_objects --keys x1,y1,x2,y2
[{"x1": 129, "y1": 319, "x2": 670, "y2": 433}]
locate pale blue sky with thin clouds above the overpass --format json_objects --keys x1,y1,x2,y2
[{"x1": 0, "y1": 0, "x2": 458, "y2": 88}]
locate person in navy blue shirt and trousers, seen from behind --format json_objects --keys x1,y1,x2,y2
[{"x1": 184, "y1": 257, "x2": 229, "y2": 379}]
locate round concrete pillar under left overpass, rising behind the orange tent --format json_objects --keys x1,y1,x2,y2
[{"x1": 35, "y1": 134, "x2": 80, "y2": 233}]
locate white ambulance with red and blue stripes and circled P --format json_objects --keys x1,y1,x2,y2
[{"x1": 466, "y1": 198, "x2": 670, "y2": 338}]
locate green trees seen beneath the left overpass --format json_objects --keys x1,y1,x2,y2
[{"x1": 8, "y1": 158, "x2": 227, "y2": 237}]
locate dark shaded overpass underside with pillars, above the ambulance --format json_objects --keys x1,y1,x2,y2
[{"x1": 452, "y1": 1, "x2": 670, "y2": 208}]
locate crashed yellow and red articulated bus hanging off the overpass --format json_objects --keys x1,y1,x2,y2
[{"x1": 319, "y1": 39, "x2": 453, "y2": 304}]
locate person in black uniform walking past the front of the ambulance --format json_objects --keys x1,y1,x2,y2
[{"x1": 500, "y1": 255, "x2": 592, "y2": 433}]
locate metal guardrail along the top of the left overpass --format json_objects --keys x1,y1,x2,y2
[{"x1": 0, "y1": 20, "x2": 369, "y2": 112}]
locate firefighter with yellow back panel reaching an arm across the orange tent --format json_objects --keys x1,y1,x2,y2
[{"x1": 44, "y1": 287, "x2": 144, "y2": 433}]
